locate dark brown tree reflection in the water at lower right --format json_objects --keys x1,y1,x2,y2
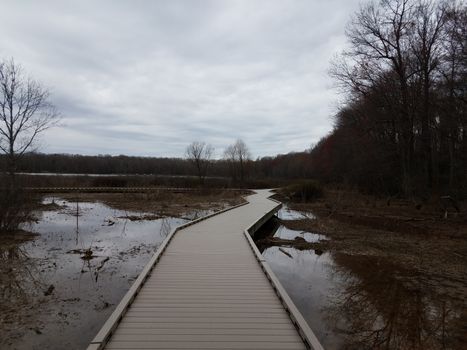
[{"x1": 324, "y1": 254, "x2": 467, "y2": 350}]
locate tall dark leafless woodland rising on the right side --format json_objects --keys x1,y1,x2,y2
[{"x1": 311, "y1": 0, "x2": 467, "y2": 197}]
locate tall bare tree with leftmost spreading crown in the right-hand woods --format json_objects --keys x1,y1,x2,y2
[{"x1": 331, "y1": 0, "x2": 414, "y2": 192}]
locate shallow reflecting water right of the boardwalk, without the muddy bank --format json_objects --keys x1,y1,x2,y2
[{"x1": 260, "y1": 207, "x2": 467, "y2": 350}]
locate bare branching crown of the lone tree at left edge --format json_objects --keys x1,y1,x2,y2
[{"x1": 0, "y1": 60, "x2": 59, "y2": 174}]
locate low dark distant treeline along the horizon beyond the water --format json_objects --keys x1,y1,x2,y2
[{"x1": 0, "y1": 152, "x2": 311, "y2": 179}]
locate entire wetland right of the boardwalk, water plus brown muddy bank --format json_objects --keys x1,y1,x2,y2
[{"x1": 256, "y1": 193, "x2": 467, "y2": 350}]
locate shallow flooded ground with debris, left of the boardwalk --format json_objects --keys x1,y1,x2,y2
[{"x1": 0, "y1": 197, "x2": 220, "y2": 349}]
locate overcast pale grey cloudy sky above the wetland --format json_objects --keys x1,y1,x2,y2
[{"x1": 0, "y1": 0, "x2": 359, "y2": 157}]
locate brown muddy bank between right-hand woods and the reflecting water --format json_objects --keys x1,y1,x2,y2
[{"x1": 272, "y1": 191, "x2": 467, "y2": 297}]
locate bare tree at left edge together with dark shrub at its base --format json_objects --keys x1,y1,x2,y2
[{"x1": 0, "y1": 60, "x2": 58, "y2": 232}]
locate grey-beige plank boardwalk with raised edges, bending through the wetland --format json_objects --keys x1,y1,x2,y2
[{"x1": 88, "y1": 190, "x2": 322, "y2": 350}]
